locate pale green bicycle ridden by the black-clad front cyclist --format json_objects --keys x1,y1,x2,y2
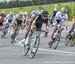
[{"x1": 24, "y1": 30, "x2": 46, "y2": 58}]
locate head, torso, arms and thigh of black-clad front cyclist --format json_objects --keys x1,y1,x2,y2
[{"x1": 26, "y1": 11, "x2": 48, "y2": 36}]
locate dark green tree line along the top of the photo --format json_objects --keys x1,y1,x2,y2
[{"x1": 0, "y1": 0, "x2": 75, "y2": 9}]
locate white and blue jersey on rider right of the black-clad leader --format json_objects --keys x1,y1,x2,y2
[{"x1": 55, "y1": 12, "x2": 68, "y2": 24}]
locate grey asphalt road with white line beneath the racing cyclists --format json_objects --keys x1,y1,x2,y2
[{"x1": 0, "y1": 23, "x2": 75, "y2": 64}]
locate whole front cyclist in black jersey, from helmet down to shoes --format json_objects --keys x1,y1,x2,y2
[{"x1": 19, "y1": 11, "x2": 48, "y2": 53}]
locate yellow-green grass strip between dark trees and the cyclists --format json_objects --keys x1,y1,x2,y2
[{"x1": 0, "y1": 2, "x2": 75, "y2": 19}]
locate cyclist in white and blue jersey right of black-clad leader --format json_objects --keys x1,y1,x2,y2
[{"x1": 48, "y1": 7, "x2": 68, "y2": 45}]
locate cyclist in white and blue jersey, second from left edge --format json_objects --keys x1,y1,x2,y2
[{"x1": 1, "y1": 12, "x2": 14, "y2": 38}]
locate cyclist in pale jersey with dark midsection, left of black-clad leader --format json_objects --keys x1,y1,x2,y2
[{"x1": 11, "y1": 12, "x2": 23, "y2": 43}]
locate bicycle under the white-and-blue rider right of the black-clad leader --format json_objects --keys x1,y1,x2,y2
[{"x1": 48, "y1": 26, "x2": 61, "y2": 49}]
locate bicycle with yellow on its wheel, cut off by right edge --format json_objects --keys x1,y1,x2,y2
[{"x1": 65, "y1": 31, "x2": 75, "y2": 46}]
